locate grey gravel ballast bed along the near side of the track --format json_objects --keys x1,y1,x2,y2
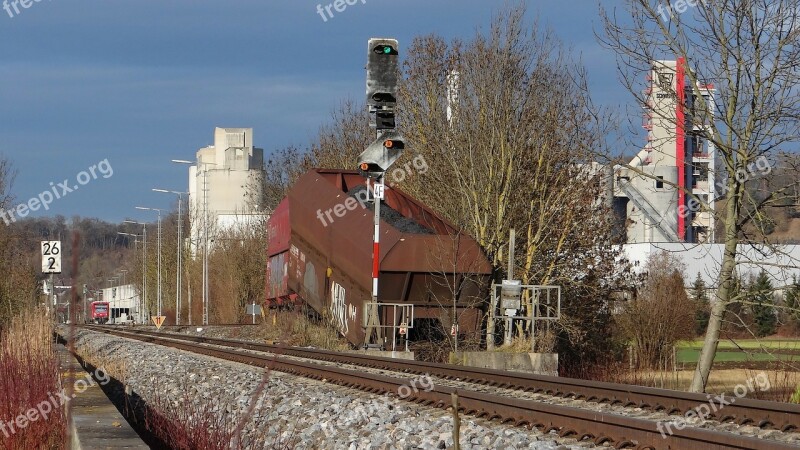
[{"x1": 70, "y1": 330, "x2": 592, "y2": 449}]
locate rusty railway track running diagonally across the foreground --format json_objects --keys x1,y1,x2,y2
[{"x1": 72, "y1": 326, "x2": 800, "y2": 449}]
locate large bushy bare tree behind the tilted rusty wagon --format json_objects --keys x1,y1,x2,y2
[{"x1": 396, "y1": 5, "x2": 624, "y2": 372}]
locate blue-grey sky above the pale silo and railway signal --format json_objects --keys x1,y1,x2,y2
[{"x1": 0, "y1": 0, "x2": 632, "y2": 222}]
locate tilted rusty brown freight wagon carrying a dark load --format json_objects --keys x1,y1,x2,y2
[{"x1": 266, "y1": 169, "x2": 491, "y2": 347}]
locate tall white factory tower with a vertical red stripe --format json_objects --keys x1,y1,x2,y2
[{"x1": 613, "y1": 59, "x2": 715, "y2": 243}]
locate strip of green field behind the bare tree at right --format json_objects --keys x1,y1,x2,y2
[{"x1": 677, "y1": 339, "x2": 800, "y2": 364}]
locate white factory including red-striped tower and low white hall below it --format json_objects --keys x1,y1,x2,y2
[{"x1": 609, "y1": 59, "x2": 800, "y2": 289}]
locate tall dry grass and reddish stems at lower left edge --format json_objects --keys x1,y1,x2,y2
[{"x1": 0, "y1": 308, "x2": 67, "y2": 450}]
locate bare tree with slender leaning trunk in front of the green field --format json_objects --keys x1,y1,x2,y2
[{"x1": 601, "y1": 0, "x2": 800, "y2": 392}]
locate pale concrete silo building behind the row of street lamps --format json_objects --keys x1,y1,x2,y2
[{"x1": 184, "y1": 128, "x2": 264, "y2": 253}]
